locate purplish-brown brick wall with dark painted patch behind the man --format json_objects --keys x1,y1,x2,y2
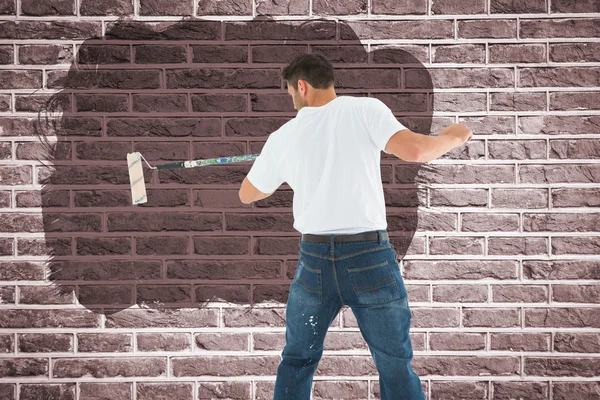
[{"x1": 0, "y1": 0, "x2": 600, "y2": 400}]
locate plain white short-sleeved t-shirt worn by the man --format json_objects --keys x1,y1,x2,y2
[{"x1": 248, "y1": 96, "x2": 406, "y2": 234}]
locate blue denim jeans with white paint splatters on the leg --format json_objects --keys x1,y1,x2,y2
[{"x1": 273, "y1": 230, "x2": 425, "y2": 400}]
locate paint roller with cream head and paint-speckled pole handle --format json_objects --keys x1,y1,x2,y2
[{"x1": 127, "y1": 151, "x2": 260, "y2": 204}]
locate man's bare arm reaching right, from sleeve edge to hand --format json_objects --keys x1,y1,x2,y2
[{"x1": 385, "y1": 124, "x2": 472, "y2": 162}]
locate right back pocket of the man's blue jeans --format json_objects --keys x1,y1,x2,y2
[{"x1": 348, "y1": 260, "x2": 400, "y2": 304}]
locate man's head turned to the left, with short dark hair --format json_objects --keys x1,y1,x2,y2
[{"x1": 281, "y1": 53, "x2": 335, "y2": 110}]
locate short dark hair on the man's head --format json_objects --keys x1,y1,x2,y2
[{"x1": 281, "y1": 53, "x2": 334, "y2": 90}]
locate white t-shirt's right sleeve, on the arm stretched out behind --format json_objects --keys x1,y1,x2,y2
[{"x1": 364, "y1": 97, "x2": 407, "y2": 154}]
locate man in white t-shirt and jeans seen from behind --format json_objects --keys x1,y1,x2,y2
[{"x1": 239, "y1": 53, "x2": 472, "y2": 400}]
